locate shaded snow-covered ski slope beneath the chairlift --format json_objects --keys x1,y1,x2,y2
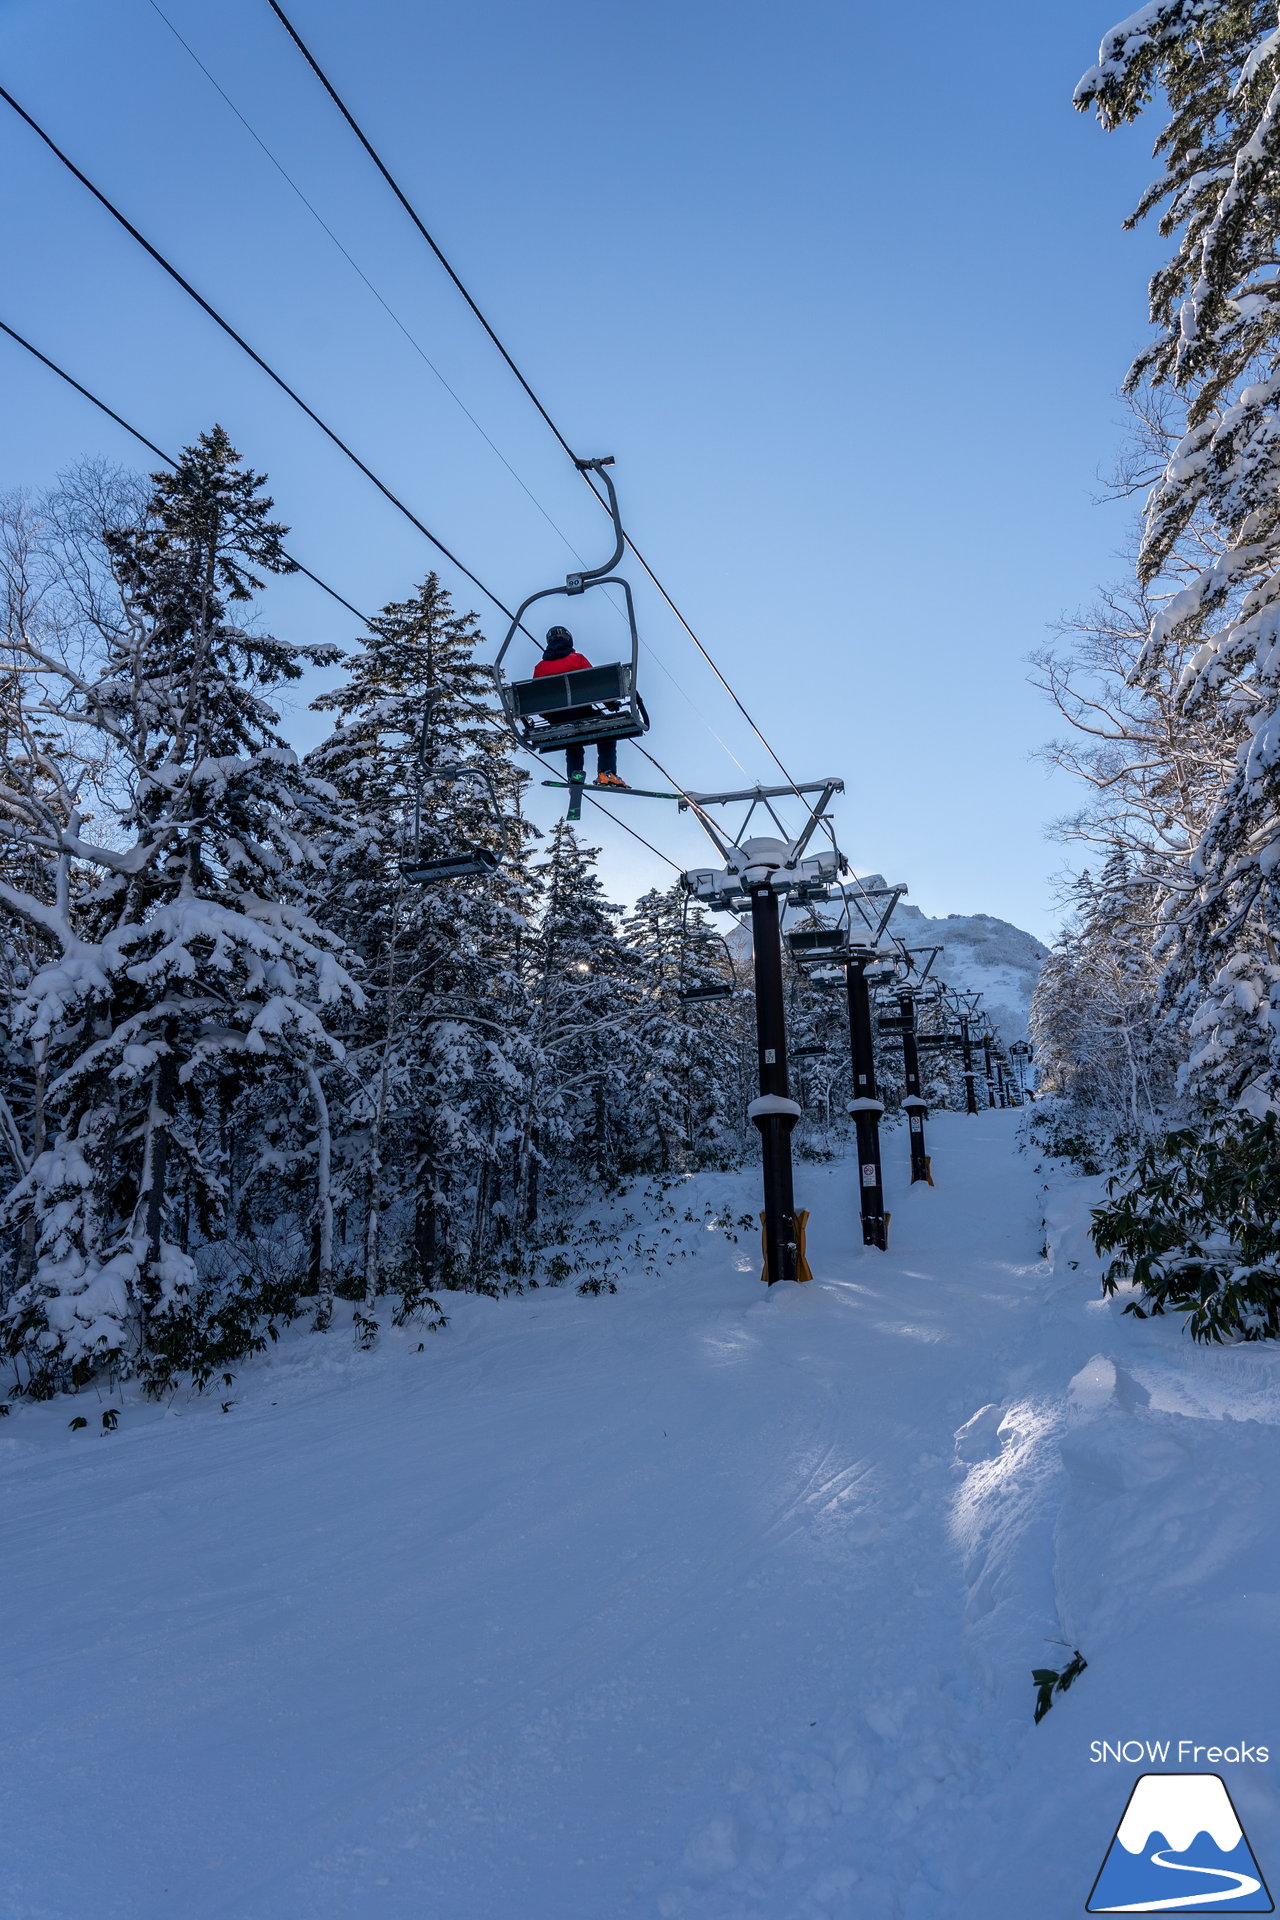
[{"x1": 0, "y1": 1114, "x2": 1280, "y2": 1920}]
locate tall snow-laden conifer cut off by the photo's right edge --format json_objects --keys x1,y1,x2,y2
[{"x1": 1077, "y1": 0, "x2": 1280, "y2": 1104}]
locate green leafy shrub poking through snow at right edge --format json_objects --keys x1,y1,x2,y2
[{"x1": 1090, "y1": 1112, "x2": 1280, "y2": 1340}]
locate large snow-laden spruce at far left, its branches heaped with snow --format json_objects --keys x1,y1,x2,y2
[{"x1": 0, "y1": 428, "x2": 359, "y2": 1392}]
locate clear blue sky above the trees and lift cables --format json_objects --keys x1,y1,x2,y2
[{"x1": 0, "y1": 0, "x2": 1159, "y2": 937}]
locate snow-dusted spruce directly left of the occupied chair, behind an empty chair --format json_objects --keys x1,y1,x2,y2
[{"x1": 307, "y1": 574, "x2": 532, "y2": 1325}]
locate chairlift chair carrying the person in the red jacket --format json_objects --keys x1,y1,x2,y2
[{"x1": 491, "y1": 457, "x2": 649, "y2": 753}]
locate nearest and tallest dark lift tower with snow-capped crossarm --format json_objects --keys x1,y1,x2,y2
[{"x1": 679, "y1": 780, "x2": 848, "y2": 1286}]
